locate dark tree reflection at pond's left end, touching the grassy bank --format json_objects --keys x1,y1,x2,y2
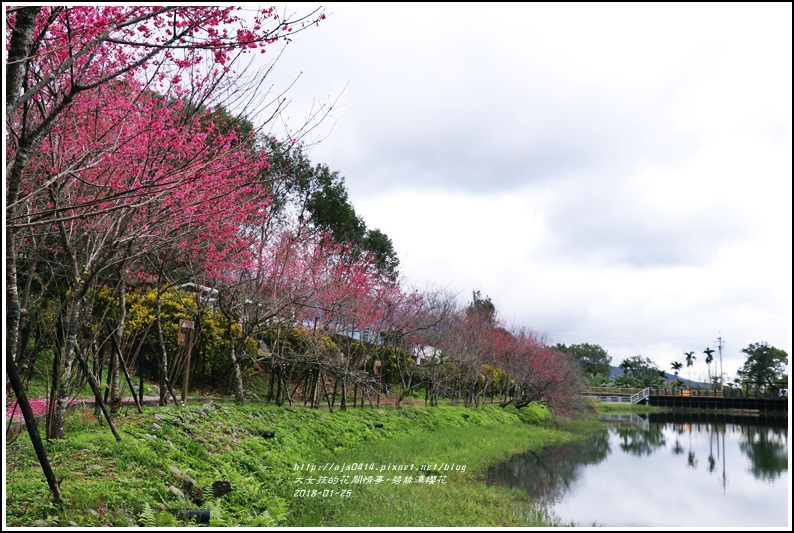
[{"x1": 487, "y1": 429, "x2": 611, "y2": 500}]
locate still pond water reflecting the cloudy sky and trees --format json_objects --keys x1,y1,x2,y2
[{"x1": 487, "y1": 412, "x2": 791, "y2": 527}]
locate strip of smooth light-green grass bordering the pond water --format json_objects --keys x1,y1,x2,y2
[{"x1": 293, "y1": 416, "x2": 581, "y2": 527}]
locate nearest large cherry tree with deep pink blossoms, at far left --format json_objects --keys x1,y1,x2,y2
[{"x1": 6, "y1": 6, "x2": 324, "y2": 437}]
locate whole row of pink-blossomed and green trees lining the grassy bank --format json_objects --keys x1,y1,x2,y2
[{"x1": 6, "y1": 6, "x2": 584, "y2": 462}]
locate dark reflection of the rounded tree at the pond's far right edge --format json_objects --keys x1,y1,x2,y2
[{"x1": 739, "y1": 426, "x2": 788, "y2": 481}]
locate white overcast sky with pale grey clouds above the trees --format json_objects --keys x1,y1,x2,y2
[{"x1": 251, "y1": 3, "x2": 792, "y2": 378}]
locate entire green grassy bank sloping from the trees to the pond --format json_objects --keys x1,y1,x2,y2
[{"x1": 6, "y1": 403, "x2": 575, "y2": 527}]
